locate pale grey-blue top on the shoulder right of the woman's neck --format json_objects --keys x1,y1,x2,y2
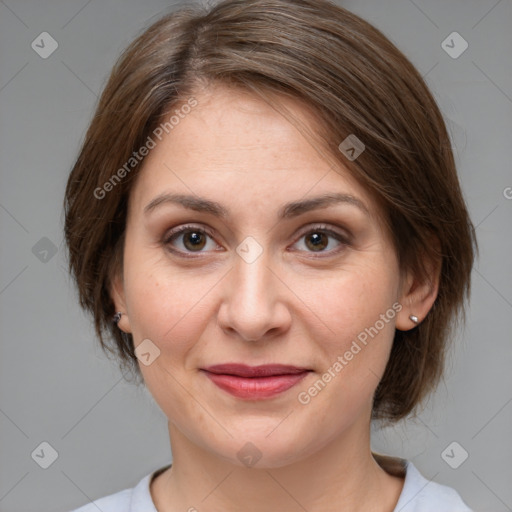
[{"x1": 394, "y1": 461, "x2": 472, "y2": 512}]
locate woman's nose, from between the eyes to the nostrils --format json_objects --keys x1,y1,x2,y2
[{"x1": 217, "y1": 246, "x2": 292, "y2": 341}]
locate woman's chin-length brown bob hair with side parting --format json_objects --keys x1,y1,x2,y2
[{"x1": 64, "y1": 0, "x2": 478, "y2": 423}]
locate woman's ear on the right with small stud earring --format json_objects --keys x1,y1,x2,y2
[{"x1": 396, "y1": 238, "x2": 442, "y2": 331}]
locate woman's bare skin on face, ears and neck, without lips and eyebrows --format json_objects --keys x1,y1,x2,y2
[{"x1": 112, "y1": 85, "x2": 438, "y2": 512}]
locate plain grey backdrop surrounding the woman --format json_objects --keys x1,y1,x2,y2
[{"x1": 0, "y1": 0, "x2": 512, "y2": 512}]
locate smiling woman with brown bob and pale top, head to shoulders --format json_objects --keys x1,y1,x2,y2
[{"x1": 65, "y1": 0, "x2": 477, "y2": 512}]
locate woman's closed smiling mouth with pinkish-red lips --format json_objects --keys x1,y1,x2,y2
[{"x1": 201, "y1": 364, "x2": 312, "y2": 400}]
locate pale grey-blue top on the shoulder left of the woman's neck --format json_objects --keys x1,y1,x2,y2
[{"x1": 71, "y1": 466, "x2": 169, "y2": 512}]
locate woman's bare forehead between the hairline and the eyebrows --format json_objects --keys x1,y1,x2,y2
[{"x1": 130, "y1": 86, "x2": 380, "y2": 223}]
